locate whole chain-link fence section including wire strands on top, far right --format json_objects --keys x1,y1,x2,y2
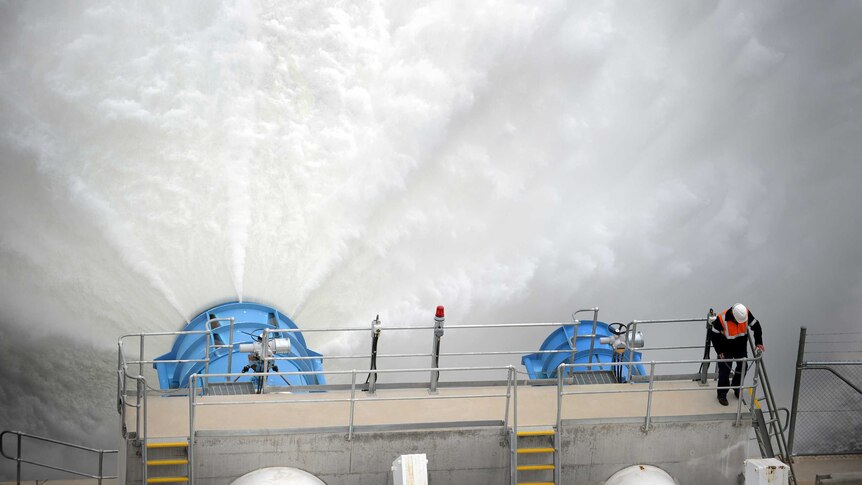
[{"x1": 791, "y1": 332, "x2": 862, "y2": 455}]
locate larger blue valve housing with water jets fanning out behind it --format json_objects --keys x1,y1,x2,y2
[{"x1": 153, "y1": 302, "x2": 326, "y2": 389}]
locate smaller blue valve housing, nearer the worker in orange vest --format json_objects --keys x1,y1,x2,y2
[{"x1": 521, "y1": 321, "x2": 646, "y2": 382}]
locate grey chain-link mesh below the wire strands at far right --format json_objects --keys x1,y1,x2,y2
[{"x1": 793, "y1": 364, "x2": 862, "y2": 455}]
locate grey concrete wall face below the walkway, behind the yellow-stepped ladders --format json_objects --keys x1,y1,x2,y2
[{"x1": 128, "y1": 415, "x2": 750, "y2": 485}]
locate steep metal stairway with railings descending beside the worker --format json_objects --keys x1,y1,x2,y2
[{"x1": 748, "y1": 334, "x2": 797, "y2": 485}]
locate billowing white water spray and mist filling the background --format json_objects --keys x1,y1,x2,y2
[{"x1": 0, "y1": 1, "x2": 862, "y2": 476}]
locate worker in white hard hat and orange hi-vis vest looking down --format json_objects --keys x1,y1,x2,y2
[{"x1": 710, "y1": 303, "x2": 765, "y2": 406}]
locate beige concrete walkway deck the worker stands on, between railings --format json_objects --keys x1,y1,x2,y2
[{"x1": 127, "y1": 381, "x2": 747, "y2": 438}]
